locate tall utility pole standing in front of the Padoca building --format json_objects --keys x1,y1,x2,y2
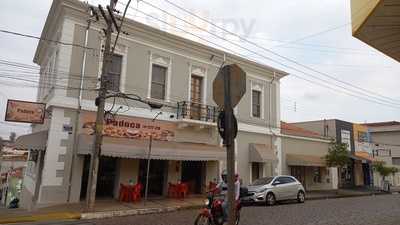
[{"x1": 86, "y1": 0, "x2": 117, "y2": 211}]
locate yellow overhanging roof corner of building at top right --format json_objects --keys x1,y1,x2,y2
[{"x1": 351, "y1": 0, "x2": 400, "y2": 61}]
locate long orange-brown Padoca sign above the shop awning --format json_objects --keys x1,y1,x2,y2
[{"x1": 82, "y1": 113, "x2": 176, "y2": 141}]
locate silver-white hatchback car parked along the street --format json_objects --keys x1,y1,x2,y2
[{"x1": 242, "y1": 176, "x2": 306, "y2": 206}]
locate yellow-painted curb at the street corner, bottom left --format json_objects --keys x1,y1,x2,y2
[{"x1": 0, "y1": 212, "x2": 81, "y2": 224}]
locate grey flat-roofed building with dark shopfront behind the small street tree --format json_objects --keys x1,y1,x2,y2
[{"x1": 293, "y1": 119, "x2": 372, "y2": 188}]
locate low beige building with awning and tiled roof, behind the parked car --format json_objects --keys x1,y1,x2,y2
[{"x1": 281, "y1": 122, "x2": 338, "y2": 191}]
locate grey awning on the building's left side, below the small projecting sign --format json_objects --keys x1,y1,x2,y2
[{"x1": 15, "y1": 130, "x2": 48, "y2": 151}]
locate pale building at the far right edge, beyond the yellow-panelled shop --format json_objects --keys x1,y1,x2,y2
[{"x1": 364, "y1": 121, "x2": 400, "y2": 187}]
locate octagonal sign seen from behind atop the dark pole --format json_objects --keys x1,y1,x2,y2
[{"x1": 213, "y1": 64, "x2": 246, "y2": 108}]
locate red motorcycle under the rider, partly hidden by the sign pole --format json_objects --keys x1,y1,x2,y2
[{"x1": 194, "y1": 191, "x2": 242, "y2": 225}]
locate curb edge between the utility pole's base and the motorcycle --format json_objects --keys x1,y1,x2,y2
[{"x1": 80, "y1": 205, "x2": 202, "y2": 220}]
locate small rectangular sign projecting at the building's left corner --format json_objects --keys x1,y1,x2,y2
[{"x1": 4, "y1": 99, "x2": 46, "y2": 124}]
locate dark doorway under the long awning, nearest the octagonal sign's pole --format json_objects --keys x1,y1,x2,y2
[{"x1": 182, "y1": 161, "x2": 206, "y2": 194}]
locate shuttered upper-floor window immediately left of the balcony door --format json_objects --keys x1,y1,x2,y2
[{"x1": 151, "y1": 64, "x2": 168, "y2": 100}]
